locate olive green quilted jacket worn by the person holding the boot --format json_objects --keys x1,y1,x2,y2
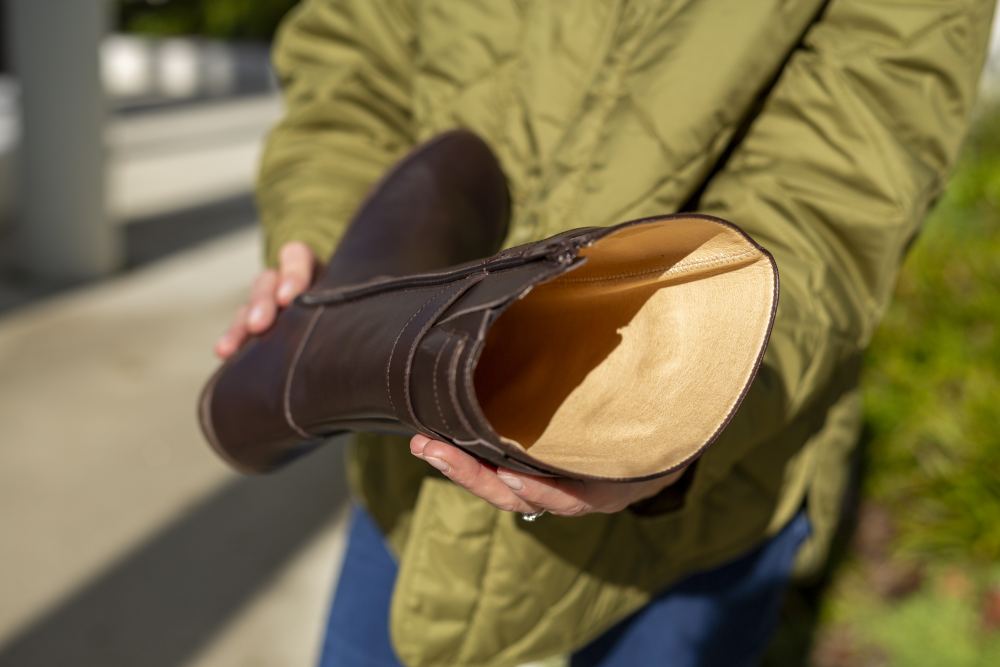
[{"x1": 258, "y1": 0, "x2": 993, "y2": 667}]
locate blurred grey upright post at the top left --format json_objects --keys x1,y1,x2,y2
[{"x1": 6, "y1": 0, "x2": 120, "y2": 280}]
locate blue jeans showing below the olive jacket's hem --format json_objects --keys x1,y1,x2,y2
[{"x1": 320, "y1": 508, "x2": 810, "y2": 667}]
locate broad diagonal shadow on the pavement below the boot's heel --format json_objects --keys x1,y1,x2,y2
[{"x1": 0, "y1": 443, "x2": 347, "y2": 667}]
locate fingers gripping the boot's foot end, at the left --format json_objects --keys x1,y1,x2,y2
[{"x1": 215, "y1": 241, "x2": 316, "y2": 359}]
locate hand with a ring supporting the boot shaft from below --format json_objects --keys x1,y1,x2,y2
[{"x1": 410, "y1": 435, "x2": 684, "y2": 516}]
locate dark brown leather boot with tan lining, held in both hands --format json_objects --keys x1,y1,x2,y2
[{"x1": 200, "y1": 132, "x2": 778, "y2": 480}]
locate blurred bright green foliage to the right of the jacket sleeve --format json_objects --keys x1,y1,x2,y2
[{"x1": 864, "y1": 111, "x2": 1000, "y2": 564}]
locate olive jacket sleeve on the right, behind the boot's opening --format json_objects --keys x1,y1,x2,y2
[{"x1": 699, "y1": 0, "x2": 993, "y2": 490}]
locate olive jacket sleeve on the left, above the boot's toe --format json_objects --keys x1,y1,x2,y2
[{"x1": 257, "y1": 0, "x2": 415, "y2": 265}]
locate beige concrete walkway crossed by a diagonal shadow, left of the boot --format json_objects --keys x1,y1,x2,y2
[{"x1": 0, "y1": 231, "x2": 345, "y2": 667}]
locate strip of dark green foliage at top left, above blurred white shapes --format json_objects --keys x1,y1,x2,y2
[{"x1": 118, "y1": 0, "x2": 297, "y2": 40}]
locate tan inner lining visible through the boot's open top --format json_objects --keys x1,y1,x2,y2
[{"x1": 475, "y1": 218, "x2": 774, "y2": 477}]
